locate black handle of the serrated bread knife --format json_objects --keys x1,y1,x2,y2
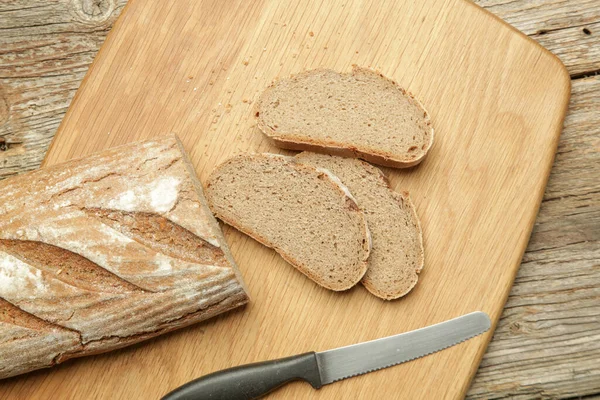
[{"x1": 162, "y1": 352, "x2": 322, "y2": 400}]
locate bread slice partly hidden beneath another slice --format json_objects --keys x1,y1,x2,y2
[{"x1": 296, "y1": 152, "x2": 424, "y2": 300}]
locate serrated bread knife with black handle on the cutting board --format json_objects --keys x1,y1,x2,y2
[{"x1": 162, "y1": 311, "x2": 491, "y2": 400}]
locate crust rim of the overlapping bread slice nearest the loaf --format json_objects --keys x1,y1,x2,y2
[{"x1": 207, "y1": 153, "x2": 372, "y2": 292}]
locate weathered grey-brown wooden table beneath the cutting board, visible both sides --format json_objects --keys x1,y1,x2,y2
[{"x1": 0, "y1": 0, "x2": 600, "y2": 399}]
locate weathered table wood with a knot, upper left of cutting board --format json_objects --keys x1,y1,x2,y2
[{"x1": 0, "y1": 0, "x2": 126, "y2": 179}]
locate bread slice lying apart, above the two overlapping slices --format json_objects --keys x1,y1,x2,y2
[{"x1": 256, "y1": 66, "x2": 433, "y2": 168}]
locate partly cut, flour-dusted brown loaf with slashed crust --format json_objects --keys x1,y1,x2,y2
[{"x1": 0, "y1": 137, "x2": 248, "y2": 378}]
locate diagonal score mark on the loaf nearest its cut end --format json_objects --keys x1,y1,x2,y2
[{"x1": 85, "y1": 208, "x2": 229, "y2": 267}]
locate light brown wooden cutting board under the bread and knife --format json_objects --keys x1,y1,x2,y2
[{"x1": 0, "y1": 0, "x2": 570, "y2": 399}]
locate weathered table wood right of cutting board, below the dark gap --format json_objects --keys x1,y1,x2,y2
[{"x1": 468, "y1": 76, "x2": 600, "y2": 399}]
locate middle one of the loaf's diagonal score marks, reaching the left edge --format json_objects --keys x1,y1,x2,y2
[{"x1": 0, "y1": 239, "x2": 144, "y2": 293}]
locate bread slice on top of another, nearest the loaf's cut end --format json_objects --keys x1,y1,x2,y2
[{"x1": 206, "y1": 154, "x2": 371, "y2": 290}]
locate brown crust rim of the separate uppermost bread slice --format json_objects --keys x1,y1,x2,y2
[{"x1": 254, "y1": 64, "x2": 435, "y2": 168}]
